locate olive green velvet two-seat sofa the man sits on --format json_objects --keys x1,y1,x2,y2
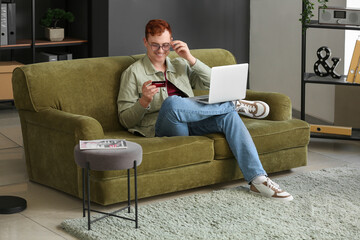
[{"x1": 13, "y1": 49, "x2": 309, "y2": 205}]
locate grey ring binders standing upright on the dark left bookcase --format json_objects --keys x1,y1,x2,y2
[{"x1": 0, "y1": 0, "x2": 16, "y2": 46}]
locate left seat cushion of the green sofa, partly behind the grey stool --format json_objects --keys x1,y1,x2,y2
[{"x1": 91, "y1": 131, "x2": 214, "y2": 178}]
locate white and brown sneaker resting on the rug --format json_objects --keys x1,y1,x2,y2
[{"x1": 250, "y1": 177, "x2": 294, "y2": 201}]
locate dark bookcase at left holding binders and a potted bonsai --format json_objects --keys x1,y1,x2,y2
[{"x1": 0, "y1": 0, "x2": 93, "y2": 105}]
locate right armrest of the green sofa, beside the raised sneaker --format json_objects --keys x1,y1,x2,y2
[{"x1": 245, "y1": 90, "x2": 292, "y2": 121}]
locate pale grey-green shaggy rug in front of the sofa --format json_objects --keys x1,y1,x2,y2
[{"x1": 61, "y1": 167, "x2": 360, "y2": 240}]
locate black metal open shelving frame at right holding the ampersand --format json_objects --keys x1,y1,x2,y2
[{"x1": 301, "y1": 9, "x2": 360, "y2": 140}]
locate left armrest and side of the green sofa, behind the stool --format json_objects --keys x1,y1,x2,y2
[{"x1": 19, "y1": 109, "x2": 104, "y2": 196}]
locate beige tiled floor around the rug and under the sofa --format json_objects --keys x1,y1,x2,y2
[{"x1": 0, "y1": 106, "x2": 360, "y2": 240}]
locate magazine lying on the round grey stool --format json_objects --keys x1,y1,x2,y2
[{"x1": 79, "y1": 139, "x2": 127, "y2": 150}]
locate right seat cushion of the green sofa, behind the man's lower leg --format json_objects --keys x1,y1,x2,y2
[{"x1": 207, "y1": 118, "x2": 310, "y2": 159}]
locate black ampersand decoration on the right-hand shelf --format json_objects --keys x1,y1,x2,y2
[{"x1": 314, "y1": 46, "x2": 341, "y2": 78}]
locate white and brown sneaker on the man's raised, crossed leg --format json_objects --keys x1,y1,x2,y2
[{"x1": 235, "y1": 100, "x2": 270, "y2": 118}]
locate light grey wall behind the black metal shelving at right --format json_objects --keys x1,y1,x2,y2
[{"x1": 250, "y1": 0, "x2": 345, "y2": 123}]
